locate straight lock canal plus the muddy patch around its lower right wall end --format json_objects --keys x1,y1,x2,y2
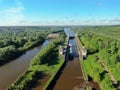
[{"x1": 51, "y1": 29, "x2": 100, "y2": 90}]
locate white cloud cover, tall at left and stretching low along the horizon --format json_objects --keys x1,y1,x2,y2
[{"x1": 0, "y1": 0, "x2": 120, "y2": 26}]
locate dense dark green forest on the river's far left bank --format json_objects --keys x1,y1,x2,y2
[{"x1": 0, "y1": 27, "x2": 61, "y2": 65}]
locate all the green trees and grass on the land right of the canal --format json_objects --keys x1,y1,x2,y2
[{"x1": 74, "y1": 26, "x2": 120, "y2": 90}]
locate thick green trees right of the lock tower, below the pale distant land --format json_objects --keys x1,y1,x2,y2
[{"x1": 79, "y1": 32, "x2": 120, "y2": 53}]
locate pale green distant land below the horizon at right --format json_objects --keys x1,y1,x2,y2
[{"x1": 73, "y1": 25, "x2": 120, "y2": 40}]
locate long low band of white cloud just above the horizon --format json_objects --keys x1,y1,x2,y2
[{"x1": 15, "y1": 18, "x2": 120, "y2": 26}]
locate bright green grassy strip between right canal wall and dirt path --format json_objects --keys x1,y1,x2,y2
[{"x1": 81, "y1": 55, "x2": 115, "y2": 90}]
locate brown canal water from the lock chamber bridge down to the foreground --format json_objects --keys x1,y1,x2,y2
[{"x1": 54, "y1": 39, "x2": 86, "y2": 90}]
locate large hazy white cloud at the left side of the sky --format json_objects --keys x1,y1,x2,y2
[{"x1": 0, "y1": 1, "x2": 24, "y2": 26}]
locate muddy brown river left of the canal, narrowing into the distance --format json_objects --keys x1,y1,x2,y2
[{"x1": 0, "y1": 40, "x2": 49, "y2": 90}]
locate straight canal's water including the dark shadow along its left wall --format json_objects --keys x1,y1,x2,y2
[{"x1": 47, "y1": 29, "x2": 87, "y2": 90}]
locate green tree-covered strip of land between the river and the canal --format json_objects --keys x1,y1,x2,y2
[{"x1": 8, "y1": 34, "x2": 65, "y2": 90}]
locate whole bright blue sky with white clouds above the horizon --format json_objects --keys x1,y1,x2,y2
[{"x1": 0, "y1": 0, "x2": 120, "y2": 26}]
